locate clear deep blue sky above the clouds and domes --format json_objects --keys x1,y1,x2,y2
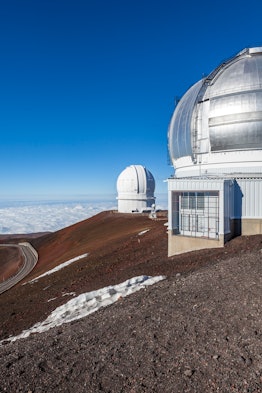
[{"x1": 0, "y1": 0, "x2": 262, "y2": 200}]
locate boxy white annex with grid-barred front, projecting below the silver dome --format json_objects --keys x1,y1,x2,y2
[{"x1": 168, "y1": 178, "x2": 235, "y2": 256}]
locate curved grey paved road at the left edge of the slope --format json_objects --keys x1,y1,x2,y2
[{"x1": 0, "y1": 243, "x2": 38, "y2": 294}]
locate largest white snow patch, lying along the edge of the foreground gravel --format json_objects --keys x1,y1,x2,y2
[{"x1": 0, "y1": 276, "x2": 166, "y2": 344}]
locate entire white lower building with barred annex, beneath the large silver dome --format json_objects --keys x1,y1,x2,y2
[{"x1": 168, "y1": 177, "x2": 262, "y2": 256}]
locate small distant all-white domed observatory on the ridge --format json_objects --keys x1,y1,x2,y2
[{"x1": 117, "y1": 165, "x2": 156, "y2": 213}]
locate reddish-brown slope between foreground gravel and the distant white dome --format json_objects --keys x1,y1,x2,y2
[{"x1": 0, "y1": 211, "x2": 262, "y2": 339}]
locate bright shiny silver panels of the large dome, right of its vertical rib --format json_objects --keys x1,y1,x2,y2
[{"x1": 204, "y1": 53, "x2": 262, "y2": 151}]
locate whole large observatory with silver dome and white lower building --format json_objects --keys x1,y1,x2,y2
[{"x1": 168, "y1": 47, "x2": 262, "y2": 256}]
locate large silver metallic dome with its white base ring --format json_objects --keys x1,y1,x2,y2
[{"x1": 168, "y1": 47, "x2": 262, "y2": 177}]
